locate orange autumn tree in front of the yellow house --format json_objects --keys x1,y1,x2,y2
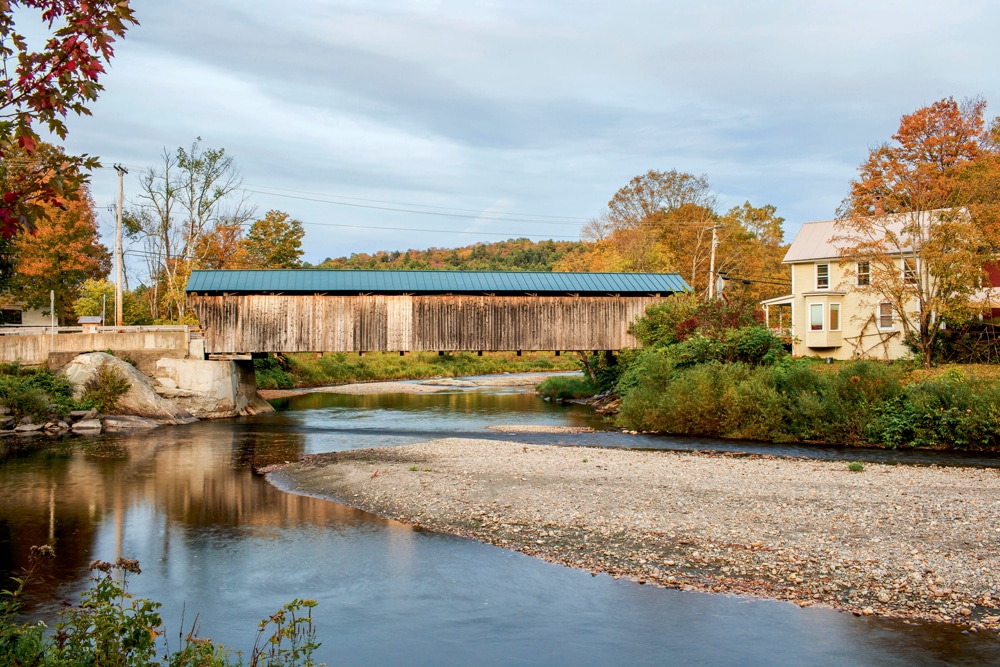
[{"x1": 834, "y1": 98, "x2": 1000, "y2": 366}]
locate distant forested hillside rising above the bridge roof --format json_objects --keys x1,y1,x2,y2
[{"x1": 317, "y1": 238, "x2": 589, "y2": 271}]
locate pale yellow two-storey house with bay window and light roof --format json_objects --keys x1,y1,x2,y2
[{"x1": 761, "y1": 220, "x2": 916, "y2": 360}]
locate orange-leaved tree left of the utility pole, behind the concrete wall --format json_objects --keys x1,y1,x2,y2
[{"x1": 11, "y1": 183, "x2": 111, "y2": 324}]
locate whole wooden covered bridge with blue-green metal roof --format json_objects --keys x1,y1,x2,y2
[{"x1": 187, "y1": 269, "x2": 690, "y2": 355}]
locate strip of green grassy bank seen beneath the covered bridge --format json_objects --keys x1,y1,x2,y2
[{"x1": 254, "y1": 352, "x2": 580, "y2": 389}]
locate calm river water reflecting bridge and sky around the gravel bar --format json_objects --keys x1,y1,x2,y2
[{"x1": 0, "y1": 389, "x2": 1000, "y2": 665}]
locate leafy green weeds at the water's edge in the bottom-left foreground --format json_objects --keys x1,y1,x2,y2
[{"x1": 0, "y1": 546, "x2": 320, "y2": 667}]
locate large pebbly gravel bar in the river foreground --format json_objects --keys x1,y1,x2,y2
[{"x1": 269, "y1": 438, "x2": 1000, "y2": 631}]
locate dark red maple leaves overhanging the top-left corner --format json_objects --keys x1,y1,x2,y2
[{"x1": 0, "y1": 0, "x2": 136, "y2": 238}]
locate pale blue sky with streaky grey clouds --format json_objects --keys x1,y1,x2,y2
[{"x1": 35, "y1": 0, "x2": 1000, "y2": 263}]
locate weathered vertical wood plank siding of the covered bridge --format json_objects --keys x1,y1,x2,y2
[{"x1": 188, "y1": 294, "x2": 660, "y2": 354}]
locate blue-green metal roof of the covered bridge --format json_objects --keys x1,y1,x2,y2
[{"x1": 187, "y1": 269, "x2": 691, "y2": 296}]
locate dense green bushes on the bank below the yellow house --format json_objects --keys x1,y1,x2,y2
[{"x1": 584, "y1": 298, "x2": 1000, "y2": 451}]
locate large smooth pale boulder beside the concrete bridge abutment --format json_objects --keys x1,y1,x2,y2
[{"x1": 63, "y1": 352, "x2": 197, "y2": 424}]
